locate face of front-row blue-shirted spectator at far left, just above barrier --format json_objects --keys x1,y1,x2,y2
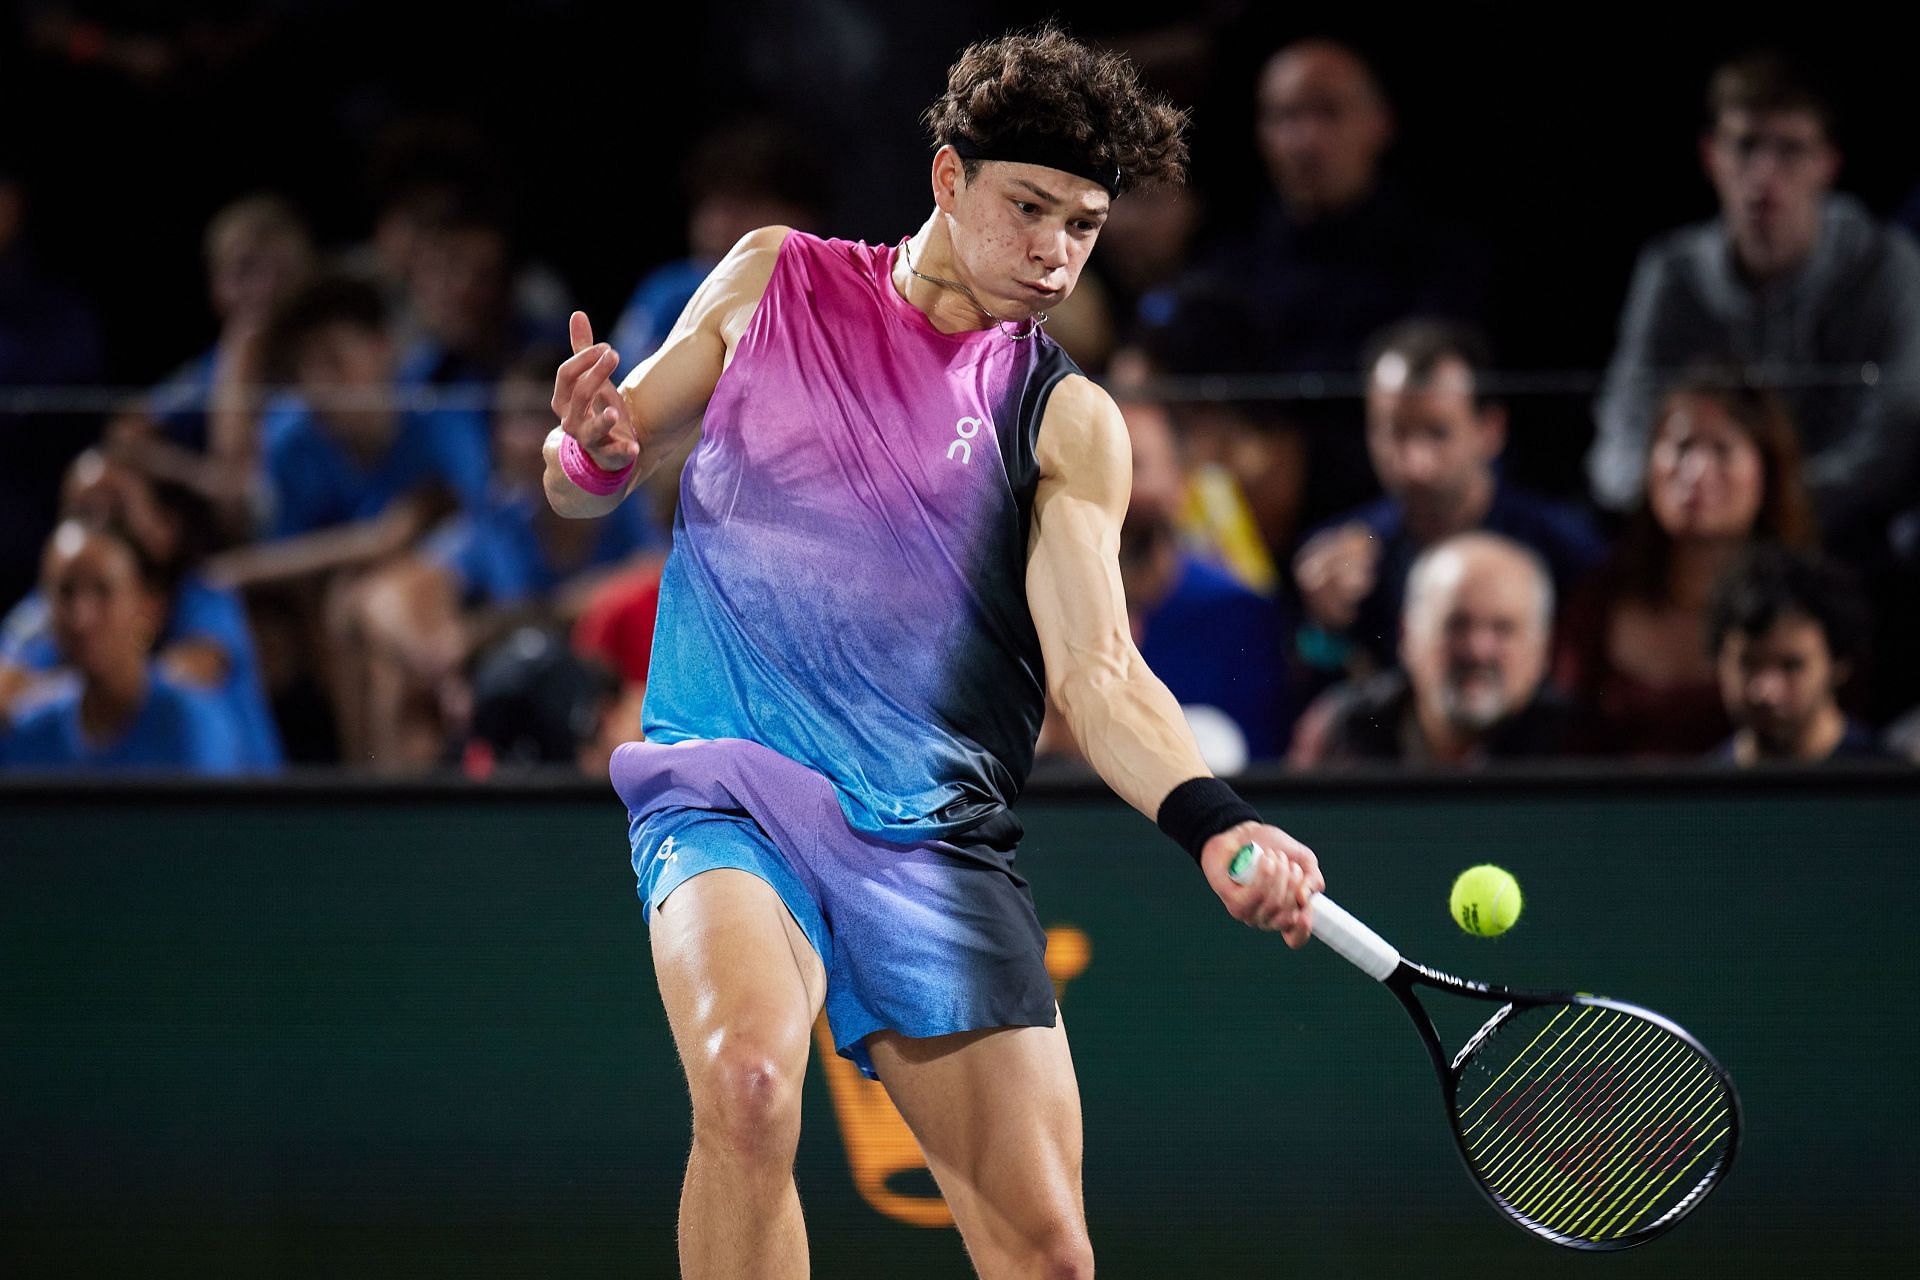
[{"x1": 40, "y1": 524, "x2": 157, "y2": 677}]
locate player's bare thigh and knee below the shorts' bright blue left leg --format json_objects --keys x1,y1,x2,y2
[{"x1": 651, "y1": 867, "x2": 828, "y2": 1144}]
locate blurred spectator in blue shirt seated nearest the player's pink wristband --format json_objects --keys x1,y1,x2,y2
[{"x1": 334, "y1": 347, "x2": 666, "y2": 771}]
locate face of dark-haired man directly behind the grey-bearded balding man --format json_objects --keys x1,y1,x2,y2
[{"x1": 1367, "y1": 355, "x2": 1505, "y2": 520}]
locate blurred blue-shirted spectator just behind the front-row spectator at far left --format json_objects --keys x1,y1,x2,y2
[{"x1": 0, "y1": 449, "x2": 284, "y2": 771}]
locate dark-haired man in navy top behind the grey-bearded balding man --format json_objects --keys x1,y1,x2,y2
[{"x1": 1294, "y1": 319, "x2": 1605, "y2": 670}]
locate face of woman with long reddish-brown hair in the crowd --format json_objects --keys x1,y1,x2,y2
[{"x1": 1647, "y1": 395, "x2": 1766, "y2": 537}]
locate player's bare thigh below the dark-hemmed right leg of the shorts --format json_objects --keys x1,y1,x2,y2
[{"x1": 866, "y1": 1019, "x2": 1085, "y2": 1249}]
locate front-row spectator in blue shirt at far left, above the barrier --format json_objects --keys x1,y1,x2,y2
[{"x1": 0, "y1": 520, "x2": 244, "y2": 773}]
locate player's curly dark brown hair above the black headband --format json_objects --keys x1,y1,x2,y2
[{"x1": 922, "y1": 23, "x2": 1187, "y2": 188}]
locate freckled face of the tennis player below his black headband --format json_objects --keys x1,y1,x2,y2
[{"x1": 950, "y1": 159, "x2": 1110, "y2": 320}]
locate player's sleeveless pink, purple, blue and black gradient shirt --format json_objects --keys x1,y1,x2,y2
[{"x1": 643, "y1": 232, "x2": 1079, "y2": 842}]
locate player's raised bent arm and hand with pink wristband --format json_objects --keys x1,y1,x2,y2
[{"x1": 543, "y1": 226, "x2": 789, "y2": 518}]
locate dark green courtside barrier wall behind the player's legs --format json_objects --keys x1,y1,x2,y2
[{"x1": 0, "y1": 775, "x2": 1920, "y2": 1280}]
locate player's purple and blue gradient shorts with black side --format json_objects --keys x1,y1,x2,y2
[{"x1": 611, "y1": 739, "x2": 1056, "y2": 1077}]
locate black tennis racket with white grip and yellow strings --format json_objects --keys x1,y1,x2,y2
[{"x1": 1229, "y1": 848, "x2": 1740, "y2": 1249}]
